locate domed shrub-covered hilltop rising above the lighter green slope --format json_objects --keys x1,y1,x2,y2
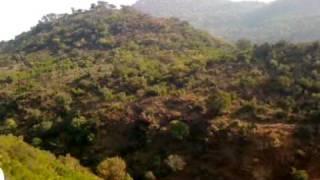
[{"x1": 0, "y1": 5, "x2": 222, "y2": 52}]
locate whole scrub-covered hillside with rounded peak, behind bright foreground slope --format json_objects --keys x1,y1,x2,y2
[{"x1": 0, "y1": 2, "x2": 320, "y2": 180}]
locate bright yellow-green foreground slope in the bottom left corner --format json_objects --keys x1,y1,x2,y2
[{"x1": 0, "y1": 136, "x2": 99, "y2": 180}]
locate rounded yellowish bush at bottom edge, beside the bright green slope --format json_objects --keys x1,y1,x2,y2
[{"x1": 97, "y1": 157, "x2": 132, "y2": 180}]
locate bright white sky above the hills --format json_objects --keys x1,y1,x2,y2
[{"x1": 0, "y1": 0, "x2": 272, "y2": 40}]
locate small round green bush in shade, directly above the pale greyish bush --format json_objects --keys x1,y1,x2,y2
[{"x1": 169, "y1": 120, "x2": 190, "y2": 140}]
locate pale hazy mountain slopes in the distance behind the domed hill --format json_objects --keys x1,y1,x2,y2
[{"x1": 134, "y1": 0, "x2": 320, "y2": 43}]
